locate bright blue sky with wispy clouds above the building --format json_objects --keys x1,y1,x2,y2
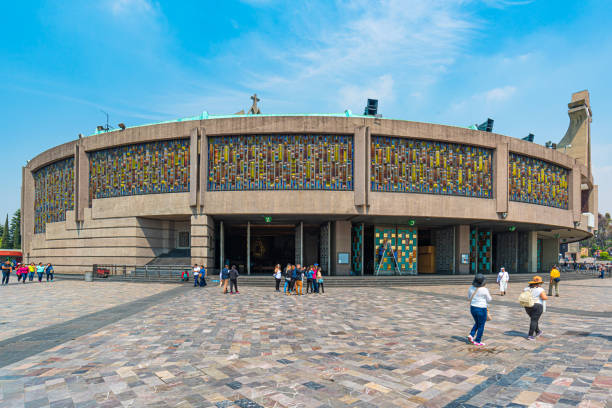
[{"x1": 0, "y1": 0, "x2": 612, "y2": 219}]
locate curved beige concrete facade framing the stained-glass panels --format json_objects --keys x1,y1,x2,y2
[{"x1": 21, "y1": 94, "x2": 597, "y2": 274}]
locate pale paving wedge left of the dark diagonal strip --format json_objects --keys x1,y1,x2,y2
[{"x1": 0, "y1": 275, "x2": 178, "y2": 340}]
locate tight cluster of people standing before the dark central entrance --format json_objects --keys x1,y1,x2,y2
[{"x1": 272, "y1": 264, "x2": 325, "y2": 295}]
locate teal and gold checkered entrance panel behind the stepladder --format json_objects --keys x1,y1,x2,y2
[{"x1": 374, "y1": 227, "x2": 418, "y2": 275}]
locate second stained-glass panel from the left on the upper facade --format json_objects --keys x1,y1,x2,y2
[{"x1": 89, "y1": 139, "x2": 189, "y2": 200}]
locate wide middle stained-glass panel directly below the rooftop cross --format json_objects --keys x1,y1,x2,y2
[{"x1": 208, "y1": 135, "x2": 353, "y2": 191}]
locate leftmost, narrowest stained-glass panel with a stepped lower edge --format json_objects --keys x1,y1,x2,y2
[{"x1": 33, "y1": 157, "x2": 74, "y2": 234}]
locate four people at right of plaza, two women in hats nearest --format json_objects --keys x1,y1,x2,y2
[{"x1": 468, "y1": 265, "x2": 561, "y2": 346}]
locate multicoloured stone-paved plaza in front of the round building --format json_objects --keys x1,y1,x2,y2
[{"x1": 0, "y1": 278, "x2": 612, "y2": 408}]
